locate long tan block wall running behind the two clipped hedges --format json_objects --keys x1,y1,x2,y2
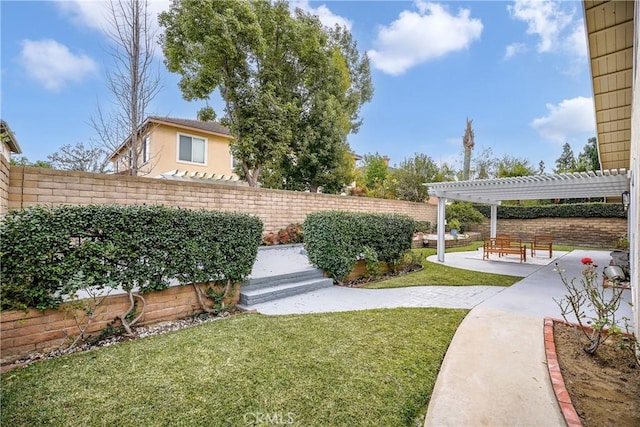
[{"x1": 8, "y1": 167, "x2": 437, "y2": 232}]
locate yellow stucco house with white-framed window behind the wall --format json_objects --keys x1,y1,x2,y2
[{"x1": 109, "y1": 116, "x2": 237, "y2": 179}]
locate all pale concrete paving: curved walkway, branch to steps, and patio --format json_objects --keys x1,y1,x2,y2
[{"x1": 252, "y1": 250, "x2": 631, "y2": 426}]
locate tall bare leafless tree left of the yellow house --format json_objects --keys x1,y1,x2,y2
[{"x1": 92, "y1": 0, "x2": 160, "y2": 175}]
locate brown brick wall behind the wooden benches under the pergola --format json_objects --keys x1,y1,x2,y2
[{"x1": 472, "y1": 218, "x2": 627, "y2": 248}]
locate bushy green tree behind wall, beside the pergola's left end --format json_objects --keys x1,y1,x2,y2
[{"x1": 391, "y1": 153, "x2": 441, "y2": 202}]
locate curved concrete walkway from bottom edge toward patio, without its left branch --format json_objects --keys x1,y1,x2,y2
[{"x1": 425, "y1": 250, "x2": 631, "y2": 426}]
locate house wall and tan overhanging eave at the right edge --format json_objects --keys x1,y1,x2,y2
[{"x1": 583, "y1": 0, "x2": 640, "y2": 337}]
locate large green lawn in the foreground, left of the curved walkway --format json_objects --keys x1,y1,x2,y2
[{"x1": 0, "y1": 308, "x2": 467, "y2": 426}]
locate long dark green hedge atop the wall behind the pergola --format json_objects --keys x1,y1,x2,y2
[{"x1": 474, "y1": 203, "x2": 626, "y2": 219}]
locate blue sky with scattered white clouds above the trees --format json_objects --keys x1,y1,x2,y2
[{"x1": 0, "y1": 0, "x2": 595, "y2": 172}]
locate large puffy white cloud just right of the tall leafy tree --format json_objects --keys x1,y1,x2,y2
[{"x1": 368, "y1": 0, "x2": 483, "y2": 75}]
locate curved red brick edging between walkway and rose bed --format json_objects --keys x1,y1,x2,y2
[{"x1": 544, "y1": 317, "x2": 583, "y2": 427}]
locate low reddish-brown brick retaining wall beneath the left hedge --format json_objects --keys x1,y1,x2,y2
[{"x1": 0, "y1": 285, "x2": 235, "y2": 364}]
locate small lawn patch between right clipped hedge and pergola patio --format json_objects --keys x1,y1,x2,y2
[{"x1": 363, "y1": 242, "x2": 522, "y2": 289}]
